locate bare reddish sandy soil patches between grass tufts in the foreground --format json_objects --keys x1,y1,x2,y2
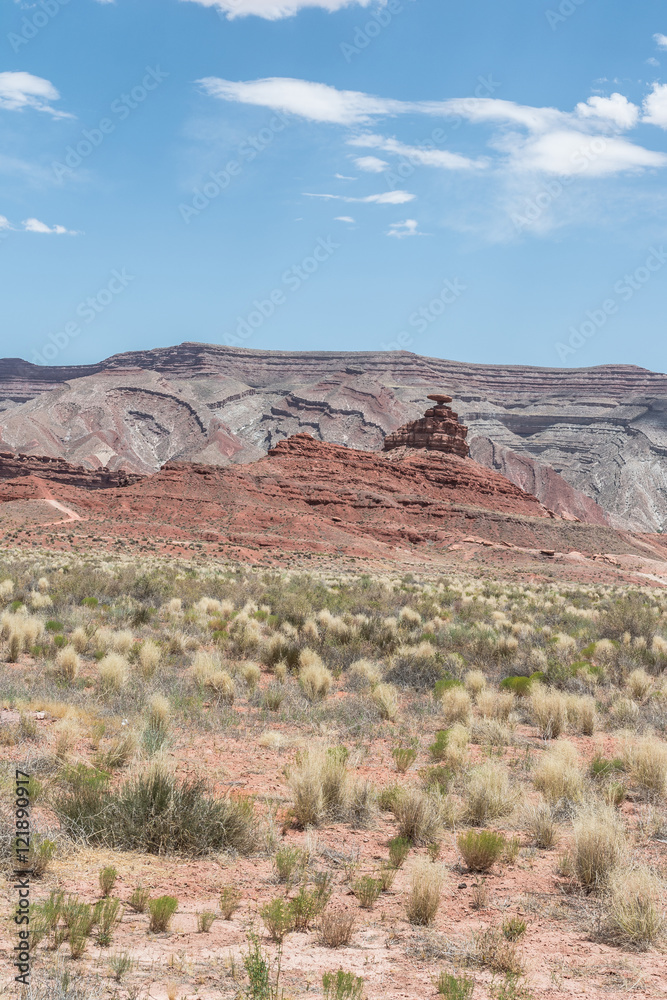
[{"x1": 3, "y1": 696, "x2": 667, "y2": 1000}]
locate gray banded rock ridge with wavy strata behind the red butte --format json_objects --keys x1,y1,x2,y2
[{"x1": 0, "y1": 343, "x2": 667, "y2": 531}]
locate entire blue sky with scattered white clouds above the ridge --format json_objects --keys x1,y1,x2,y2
[{"x1": 0, "y1": 0, "x2": 667, "y2": 371}]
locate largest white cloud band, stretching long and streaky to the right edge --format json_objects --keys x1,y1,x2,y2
[{"x1": 199, "y1": 77, "x2": 667, "y2": 187}]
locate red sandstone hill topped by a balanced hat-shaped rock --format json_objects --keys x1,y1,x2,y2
[{"x1": 0, "y1": 394, "x2": 664, "y2": 576}]
